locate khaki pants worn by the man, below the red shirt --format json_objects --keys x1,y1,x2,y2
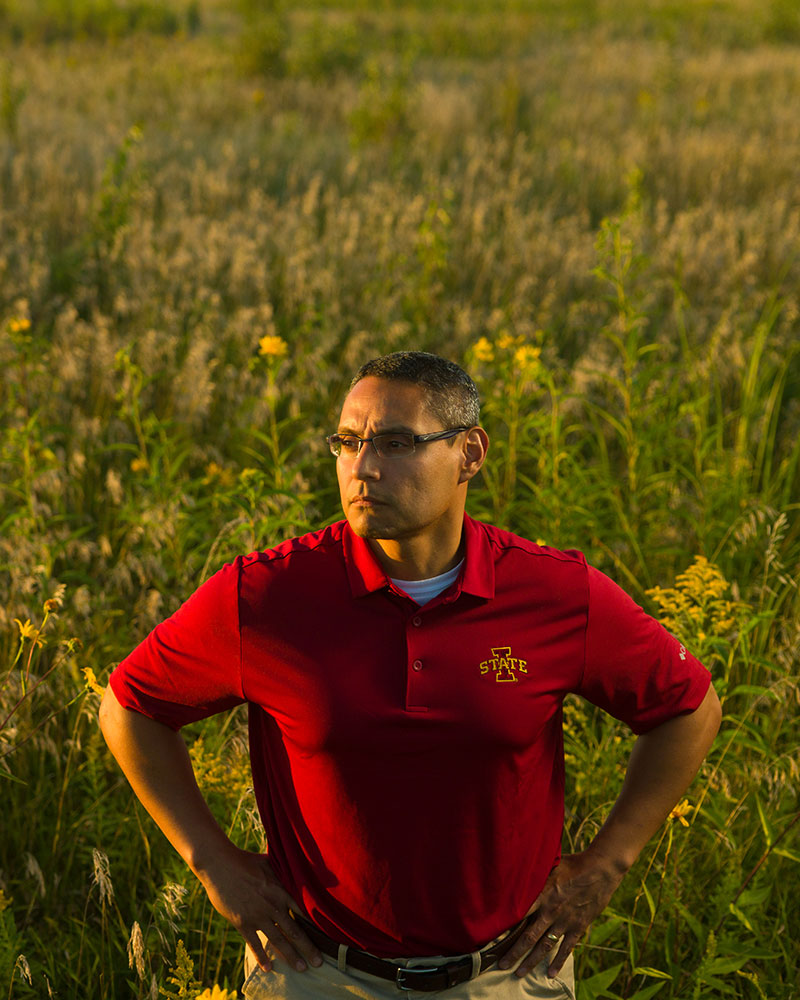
[{"x1": 242, "y1": 939, "x2": 575, "y2": 1000}]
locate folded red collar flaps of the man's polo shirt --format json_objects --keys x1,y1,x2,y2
[{"x1": 342, "y1": 514, "x2": 494, "y2": 599}]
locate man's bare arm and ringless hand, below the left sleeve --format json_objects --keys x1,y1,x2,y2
[{"x1": 100, "y1": 687, "x2": 321, "y2": 971}]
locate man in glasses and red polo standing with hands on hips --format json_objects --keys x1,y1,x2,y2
[{"x1": 101, "y1": 352, "x2": 720, "y2": 1000}]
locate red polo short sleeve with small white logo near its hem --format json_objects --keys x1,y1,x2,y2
[{"x1": 577, "y1": 566, "x2": 711, "y2": 733}]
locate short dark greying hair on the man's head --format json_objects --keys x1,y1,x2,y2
[{"x1": 350, "y1": 351, "x2": 481, "y2": 429}]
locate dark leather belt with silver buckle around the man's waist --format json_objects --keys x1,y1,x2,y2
[{"x1": 294, "y1": 913, "x2": 527, "y2": 993}]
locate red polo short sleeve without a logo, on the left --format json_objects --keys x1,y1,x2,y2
[{"x1": 109, "y1": 560, "x2": 245, "y2": 729}]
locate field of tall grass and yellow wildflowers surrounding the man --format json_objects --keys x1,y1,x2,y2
[{"x1": 0, "y1": 0, "x2": 800, "y2": 1000}]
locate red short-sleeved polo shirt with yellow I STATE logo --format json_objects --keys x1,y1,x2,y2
[{"x1": 111, "y1": 517, "x2": 710, "y2": 957}]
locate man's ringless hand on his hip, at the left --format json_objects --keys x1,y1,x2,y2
[{"x1": 196, "y1": 845, "x2": 322, "y2": 972}]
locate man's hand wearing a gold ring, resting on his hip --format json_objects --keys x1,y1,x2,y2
[{"x1": 499, "y1": 850, "x2": 625, "y2": 977}]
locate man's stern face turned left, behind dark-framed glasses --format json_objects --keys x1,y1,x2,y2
[{"x1": 336, "y1": 376, "x2": 467, "y2": 539}]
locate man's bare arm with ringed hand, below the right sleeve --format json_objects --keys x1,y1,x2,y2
[{"x1": 500, "y1": 686, "x2": 722, "y2": 976}]
